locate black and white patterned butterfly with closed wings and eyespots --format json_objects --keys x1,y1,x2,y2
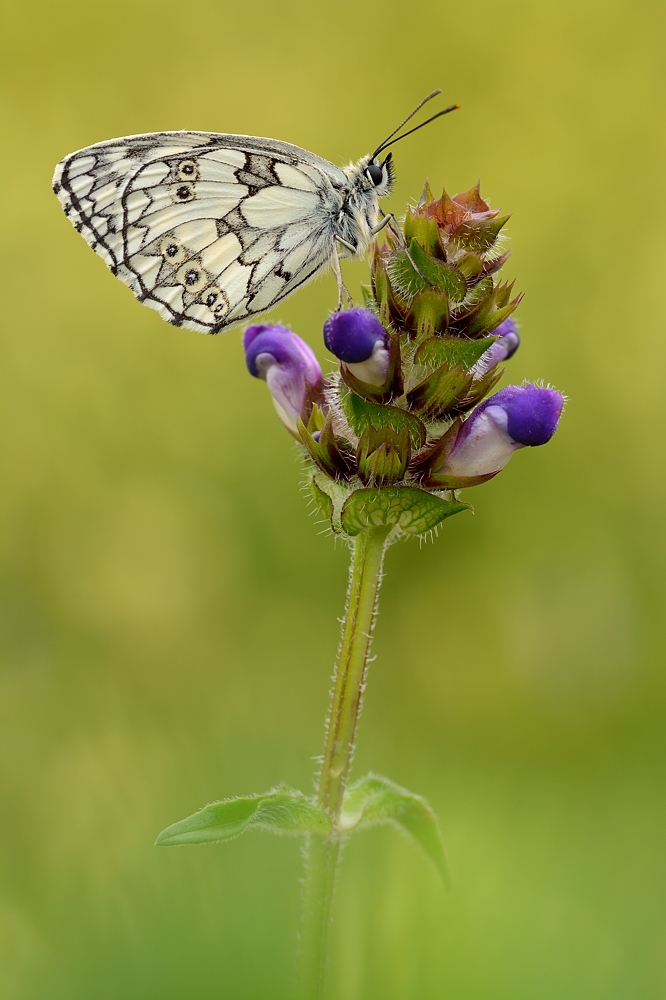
[{"x1": 53, "y1": 90, "x2": 457, "y2": 333}]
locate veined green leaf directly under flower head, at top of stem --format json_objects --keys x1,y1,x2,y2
[{"x1": 341, "y1": 486, "x2": 471, "y2": 535}]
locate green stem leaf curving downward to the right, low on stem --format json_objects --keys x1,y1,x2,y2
[{"x1": 340, "y1": 774, "x2": 451, "y2": 888}]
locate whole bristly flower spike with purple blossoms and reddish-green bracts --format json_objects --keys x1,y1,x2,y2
[{"x1": 245, "y1": 183, "x2": 564, "y2": 524}]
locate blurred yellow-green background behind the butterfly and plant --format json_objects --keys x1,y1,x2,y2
[{"x1": 2, "y1": 0, "x2": 666, "y2": 1000}]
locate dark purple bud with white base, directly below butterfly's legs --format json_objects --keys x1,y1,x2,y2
[{"x1": 324, "y1": 309, "x2": 389, "y2": 385}]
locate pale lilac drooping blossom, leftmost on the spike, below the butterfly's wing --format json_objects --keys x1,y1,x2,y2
[{"x1": 243, "y1": 326, "x2": 323, "y2": 437}]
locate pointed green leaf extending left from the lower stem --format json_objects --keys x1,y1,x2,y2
[{"x1": 155, "y1": 786, "x2": 331, "y2": 847}]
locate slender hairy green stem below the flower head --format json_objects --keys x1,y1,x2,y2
[{"x1": 299, "y1": 527, "x2": 391, "y2": 1000}]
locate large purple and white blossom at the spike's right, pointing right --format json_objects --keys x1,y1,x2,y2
[{"x1": 433, "y1": 385, "x2": 564, "y2": 477}]
